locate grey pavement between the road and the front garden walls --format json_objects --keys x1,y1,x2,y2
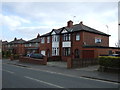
[{"x1": 4, "y1": 60, "x2": 120, "y2": 83}]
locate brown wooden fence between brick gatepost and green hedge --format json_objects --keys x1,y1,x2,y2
[{"x1": 72, "y1": 59, "x2": 98, "y2": 68}]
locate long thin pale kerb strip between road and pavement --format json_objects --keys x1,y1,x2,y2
[{"x1": 3, "y1": 65, "x2": 119, "y2": 84}]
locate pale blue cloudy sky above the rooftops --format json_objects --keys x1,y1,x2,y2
[{"x1": 0, "y1": 2, "x2": 118, "y2": 47}]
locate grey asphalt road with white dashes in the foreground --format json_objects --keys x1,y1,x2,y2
[{"x1": 2, "y1": 60, "x2": 118, "y2": 88}]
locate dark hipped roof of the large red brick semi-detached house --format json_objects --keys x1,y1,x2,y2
[{"x1": 42, "y1": 23, "x2": 110, "y2": 36}]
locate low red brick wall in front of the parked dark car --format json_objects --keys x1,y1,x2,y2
[{"x1": 19, "y1": 57, "x2": 47, "y2": 65}]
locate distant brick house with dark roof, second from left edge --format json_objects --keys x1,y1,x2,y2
[{"x1": 6, "y1": 38, "x2": 25, "y2": 55}]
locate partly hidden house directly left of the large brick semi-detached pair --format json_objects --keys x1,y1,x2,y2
[{"x1": 24, "y1": 34, "x2": 40, "y2": 54}]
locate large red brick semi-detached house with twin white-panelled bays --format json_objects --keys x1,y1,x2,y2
[{"x1": 39, "y1": 20, "x2": 120, "y2": 61}]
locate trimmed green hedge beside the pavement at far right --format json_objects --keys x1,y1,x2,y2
[{"x1": 99, "y1": 56, "x2": 120, "y2": 68}]
